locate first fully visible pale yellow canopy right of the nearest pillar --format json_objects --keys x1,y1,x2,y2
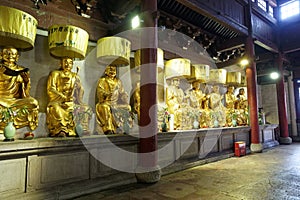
[{"x1": 165, "y1": 58, "x2": 191, "y2": 79}]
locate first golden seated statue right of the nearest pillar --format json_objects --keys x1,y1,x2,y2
[{"x1": 166, "y1": 78, "x2": 186, "y2": 130}]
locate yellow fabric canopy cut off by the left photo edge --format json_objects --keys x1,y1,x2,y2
[{"x1": 0, "y1": 6, "x2": 37, "y2": 50}]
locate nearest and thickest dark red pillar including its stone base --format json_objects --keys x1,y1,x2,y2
[{"x1": 136, "y1": 0, "x2": 161, "y2": 183}]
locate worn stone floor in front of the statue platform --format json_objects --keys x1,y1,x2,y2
[{"x1": 76, "y1": 143, "x2": 300, "y2": 200}]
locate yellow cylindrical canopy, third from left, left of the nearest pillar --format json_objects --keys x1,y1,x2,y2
[{"x1": 97, "y1": 37, "x2": 131, "y2": 66}]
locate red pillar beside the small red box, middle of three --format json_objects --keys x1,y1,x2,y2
[{"x1": 246, "y1": 36, "x2": 263, "y2": 152}]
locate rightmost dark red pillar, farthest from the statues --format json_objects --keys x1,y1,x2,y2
[{"x1": 276, "y1": 53, "x2": 292, "y2": 144}]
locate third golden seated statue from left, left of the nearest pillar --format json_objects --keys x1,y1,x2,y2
[{"x1": 96, "y1": 65, "x2": 132, "y2": 135}]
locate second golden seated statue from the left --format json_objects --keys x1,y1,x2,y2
[{"x1": 46, "y1": 58, "x2": 79, "y2": 137}]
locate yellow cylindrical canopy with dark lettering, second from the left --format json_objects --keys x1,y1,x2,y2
[{"x1": 48, "y1": 25, "x2": 89, "y2": 59}]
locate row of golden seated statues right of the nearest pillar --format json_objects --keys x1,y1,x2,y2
[{"x1": 160, "y1": 78, "x2": 248, "y2": 130}]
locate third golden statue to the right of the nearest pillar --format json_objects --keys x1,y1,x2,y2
[{"x1": 210, "y1": 85, "x2": 226, "y2": 126}]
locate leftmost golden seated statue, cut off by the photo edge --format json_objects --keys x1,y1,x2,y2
[{"x1": 0, "y1": 47, "x2": 39, "y2": 132}]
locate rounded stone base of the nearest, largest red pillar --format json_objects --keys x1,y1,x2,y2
[{"x1": 135, "y1": 166, "x2": 162, "y2": 183}]
